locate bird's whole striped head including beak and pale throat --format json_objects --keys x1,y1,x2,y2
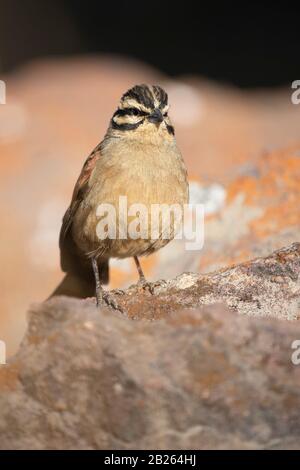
[{"x1": 111, "y1": 85, "x2": 174, "y2": 137}]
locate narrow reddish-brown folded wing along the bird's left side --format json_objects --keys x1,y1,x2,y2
[{"x1": 59, "y1": 144, "x2": 101, "y2": 271}]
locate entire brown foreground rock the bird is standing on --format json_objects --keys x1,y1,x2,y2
[{"x1": 0, "y1": 244, "x2": 300, "y2": 449}]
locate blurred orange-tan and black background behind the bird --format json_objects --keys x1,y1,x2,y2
[{"x1": 0, "y1": 0, "x2": 300, "y2": 354}]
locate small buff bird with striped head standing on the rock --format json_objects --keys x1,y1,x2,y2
[{"x1": 52, "y1": 84, "x2": 189, "y2": 309}]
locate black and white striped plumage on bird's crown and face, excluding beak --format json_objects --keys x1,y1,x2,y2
[{"x1": 111, "y1": 85, "x2": 174, "y2": 134}]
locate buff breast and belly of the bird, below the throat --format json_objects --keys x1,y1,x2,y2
[{"x1": 73, "y1": 135, "x2": 188, "y2": 258}]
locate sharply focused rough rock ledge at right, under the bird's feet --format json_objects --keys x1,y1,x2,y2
[{"x1": 116, "y1": 243, "x2": 300, "y2": 320}]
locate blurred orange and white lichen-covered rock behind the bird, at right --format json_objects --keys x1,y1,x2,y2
[{"x1": 196, "y1": 146, "x2": 300, "y2": 272}]
